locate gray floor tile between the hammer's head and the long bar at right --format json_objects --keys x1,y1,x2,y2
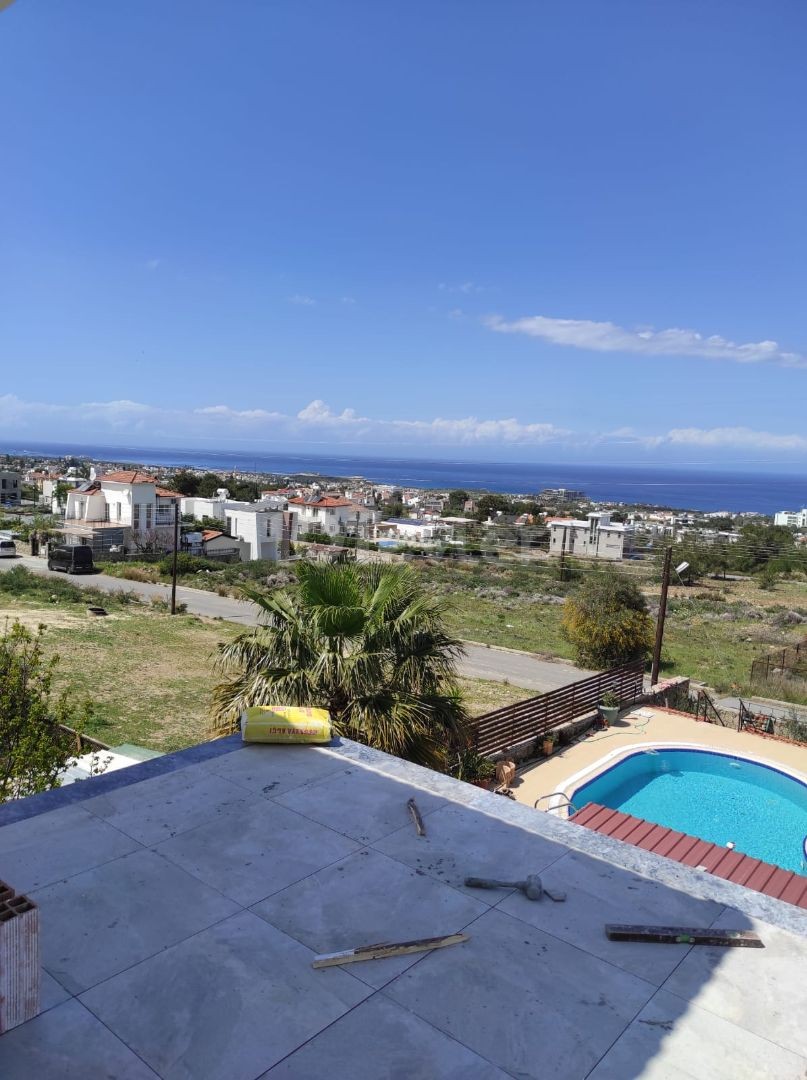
[{"x1": 499, "y1": 852, "x2": 723, "y2": 986}]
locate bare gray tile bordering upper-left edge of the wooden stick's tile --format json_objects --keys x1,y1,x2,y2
[{"x1": 154, "y1": 796, "x2": 358, "y2": 907}]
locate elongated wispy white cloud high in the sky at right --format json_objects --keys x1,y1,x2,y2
[{"x1": 483, "y1": 315, "x2": 807, "y2": 367}]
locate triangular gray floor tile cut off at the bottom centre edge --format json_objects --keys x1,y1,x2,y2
[{"x1": 260, "y1": 996, "x2": 507, "y2": 1080}]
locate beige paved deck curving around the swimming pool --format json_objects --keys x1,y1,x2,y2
[{"x1": 513, "y1": 705, "x2": 807, "y2": 816}]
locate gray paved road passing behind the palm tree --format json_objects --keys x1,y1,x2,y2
[{"x1": 0, "y1": 555, "x2": 593, "y2": 692}]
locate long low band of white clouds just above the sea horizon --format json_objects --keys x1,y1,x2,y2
[{"x1": 0, "y1": 394, "x2": 807, "y2": 454}]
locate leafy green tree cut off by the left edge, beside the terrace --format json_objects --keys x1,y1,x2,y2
[{"x1": 0, "y1": 622, "x2": 88, "y2": 802}]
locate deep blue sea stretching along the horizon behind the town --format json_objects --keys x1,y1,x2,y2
[{"x1": 0, "y1": 442, "x2": 807, "y2": 514}]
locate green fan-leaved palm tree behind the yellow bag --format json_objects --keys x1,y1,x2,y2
[{"x1": 213, "y1": 563, "x2": 468, "y2": 765}]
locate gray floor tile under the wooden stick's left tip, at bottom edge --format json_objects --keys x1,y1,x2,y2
[{"x1": 82, "y1": 912, "x2": 369, "y2": 1080}]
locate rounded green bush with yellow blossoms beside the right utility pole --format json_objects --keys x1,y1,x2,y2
[{"x1": 563, "y1": 570, "x2": 654, "y2": 669}]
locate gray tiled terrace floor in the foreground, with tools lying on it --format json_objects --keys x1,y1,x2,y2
[{"x1": 0, "y1": 737, "x2": 807, "y2": 1080}]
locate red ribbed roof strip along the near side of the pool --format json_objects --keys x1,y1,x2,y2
[{"x1": 569, "y1": 802, "x2": 807, "y2": 908}]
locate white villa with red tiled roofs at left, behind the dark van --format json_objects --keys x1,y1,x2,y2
[{"x1": 62, "y1": 470, "x2": 179, "y2": 551}]
